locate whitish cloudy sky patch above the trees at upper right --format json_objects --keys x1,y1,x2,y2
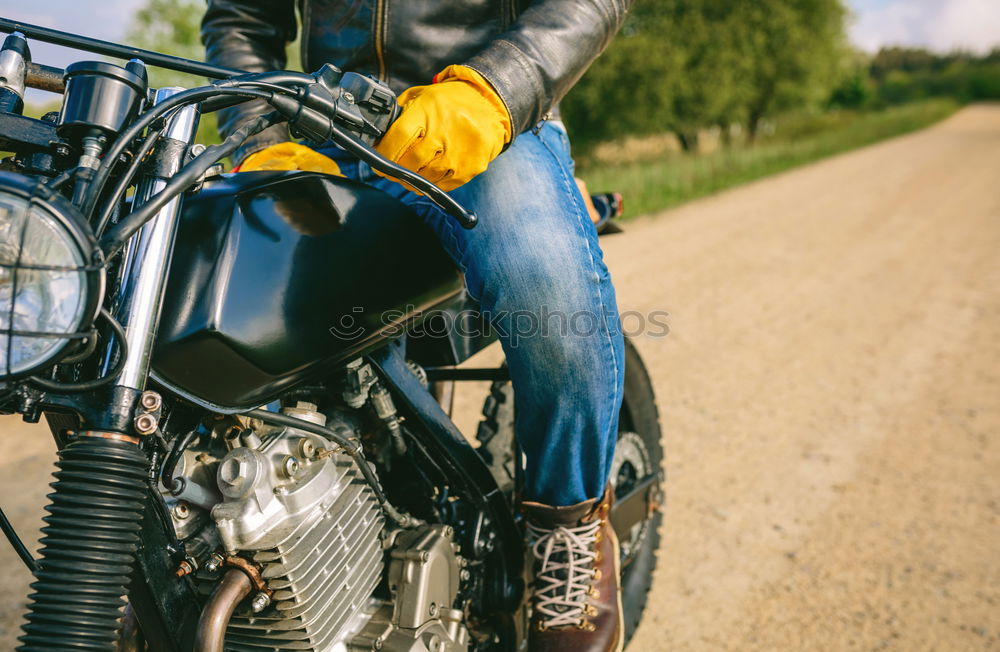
[{"x1": 850, "y1": 0, "x2": 1000, "y2": 53}]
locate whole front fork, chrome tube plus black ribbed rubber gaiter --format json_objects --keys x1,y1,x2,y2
[{"x1": 18, "y1": 88, "x2": 198, "y2": 652}]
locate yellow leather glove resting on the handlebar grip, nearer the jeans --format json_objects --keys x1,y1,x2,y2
[{"x1": 375, "y1": 66, "x2": 511, "y2": 191}]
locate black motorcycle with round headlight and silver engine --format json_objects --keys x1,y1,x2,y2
[{"x1": 0, "y1": 19, "x2": 662, "y2": 652}]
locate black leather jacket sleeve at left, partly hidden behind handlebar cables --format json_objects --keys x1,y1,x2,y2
[{"x1": 201, "y1": 0, "x2": 295, "y2": 162}]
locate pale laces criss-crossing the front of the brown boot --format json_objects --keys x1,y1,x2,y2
[{"x1": 528, "y1": 520, "x2": 601, "y2": 628}]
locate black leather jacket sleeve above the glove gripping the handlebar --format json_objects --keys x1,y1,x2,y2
[{"x1": 463, "y1": 0, "x2": 632, "y2": 134}]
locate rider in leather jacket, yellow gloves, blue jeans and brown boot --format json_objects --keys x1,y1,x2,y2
[{"x1": 202, "y1": 0, "x2": 631, "y2": 650}]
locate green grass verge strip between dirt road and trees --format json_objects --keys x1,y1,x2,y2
[{"x1": 578, "y1": 99, "x2": 960, "y2": 217}]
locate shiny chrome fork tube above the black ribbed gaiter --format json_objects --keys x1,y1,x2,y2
[{"x1": 107, "y1": 87, "x2": 199, "y2": 391}]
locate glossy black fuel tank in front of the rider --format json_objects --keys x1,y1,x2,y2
[{"x1": 153, "y1": 172, "x2": 462, "y2": 409}]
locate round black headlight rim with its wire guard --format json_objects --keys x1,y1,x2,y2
[{"x1": 0, "y1": 172, "x2": 107, "y2": 382}]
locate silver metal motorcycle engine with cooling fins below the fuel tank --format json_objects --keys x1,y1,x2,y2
[{"x1": 165, "y1": 403, "x2": 469, "y2": 652}]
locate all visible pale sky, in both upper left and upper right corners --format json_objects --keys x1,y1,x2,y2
[{"x1": 0, "y1": 0, "x2": 1000, "y2": 74}]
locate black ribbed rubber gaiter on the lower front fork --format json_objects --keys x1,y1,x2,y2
[{"x1": 17, "y1": 436, "x2": 149, "y2": 652}]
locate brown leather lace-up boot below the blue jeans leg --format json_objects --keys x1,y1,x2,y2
[{"x1": 521, "y1": 486, "x2": 625, "y2": 652}]
